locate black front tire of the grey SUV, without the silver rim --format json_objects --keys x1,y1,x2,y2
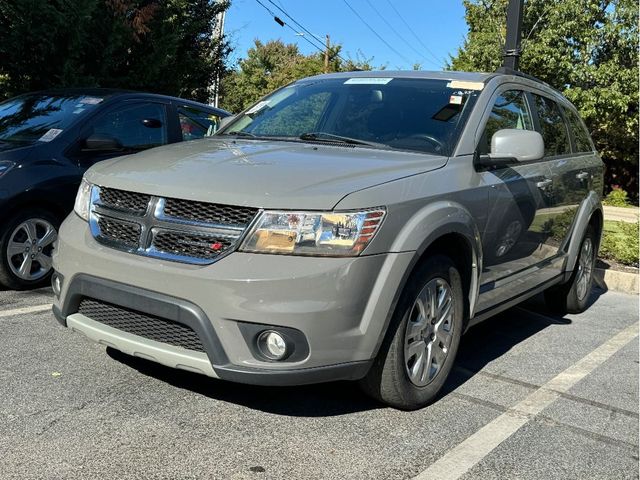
[{"x1": 360, "y1": 255, "x2": 464, "y2": 410}]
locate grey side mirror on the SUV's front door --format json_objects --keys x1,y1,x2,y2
[{"x1": 478, "y1": 128, "x2": 544, "y2": 167}]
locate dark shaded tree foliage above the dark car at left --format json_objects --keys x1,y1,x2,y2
[{"x1": 0, "y1": 0, "x2": 230, "y2": 101}]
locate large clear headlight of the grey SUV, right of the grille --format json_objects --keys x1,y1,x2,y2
[{"x1": 240, "y1": 208, "x2": 385, "y2": 256}]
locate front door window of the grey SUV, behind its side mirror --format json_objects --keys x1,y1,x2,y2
[{"x1": 478, "y1": 90, "x2": 533, "y2": 154}]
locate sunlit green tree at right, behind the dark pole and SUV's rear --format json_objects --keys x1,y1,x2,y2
[{"x1": 449, "y1": 0, "x2": 638, "y2": 199}]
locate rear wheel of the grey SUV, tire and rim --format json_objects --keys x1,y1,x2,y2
[{"x1": 544, "y1": 225, "x2": 598, "y2": 315}]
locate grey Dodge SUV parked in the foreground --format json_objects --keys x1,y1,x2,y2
[{"x1": 53, "y1": 71, "x2": 603, "y2": 409}]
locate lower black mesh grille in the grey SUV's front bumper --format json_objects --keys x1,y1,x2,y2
[{"x1": 78, "y1": 297, "x2": 205, "y2": 352}]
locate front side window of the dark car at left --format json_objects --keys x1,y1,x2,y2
[{"x1": 92, "y1": 103, "x2": 167, "y2": 150}]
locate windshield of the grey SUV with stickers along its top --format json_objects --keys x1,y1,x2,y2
[{"x1": 221, "y1": 77, "x2": 478, "y2": 155}]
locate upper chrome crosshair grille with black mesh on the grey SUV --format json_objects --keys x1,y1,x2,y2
[{"x1": 90, "y1": 186, "x2": 258, "y2": 264}]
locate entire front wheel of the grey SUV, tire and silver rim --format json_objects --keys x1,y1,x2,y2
[{"x1": 361, "y1": 255, "x2": 464, "y2": 410}]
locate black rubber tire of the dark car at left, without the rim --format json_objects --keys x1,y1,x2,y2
[{"x1": 0, "y1": 208, "x2": 60, "y2": 290}]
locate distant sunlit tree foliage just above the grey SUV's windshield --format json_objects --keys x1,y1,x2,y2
[{"x1": 222, "y1": 40, "x2": 372, "y2": 112}]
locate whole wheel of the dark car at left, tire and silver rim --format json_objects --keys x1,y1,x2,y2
[{"x1": 0, "y1": 209, "x2": 60, "y2": 290}]
